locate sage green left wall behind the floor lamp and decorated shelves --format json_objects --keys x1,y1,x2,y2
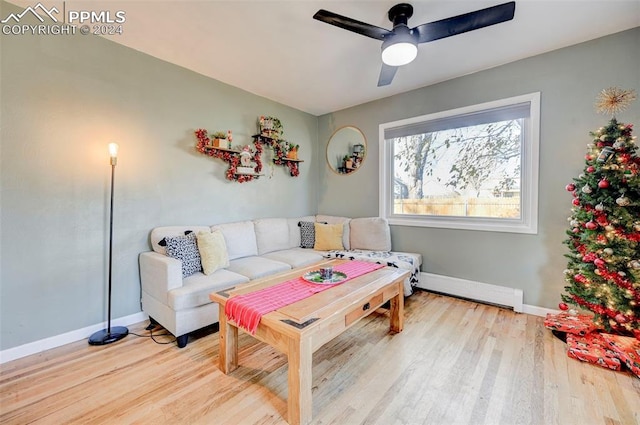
[{"x1": 0, "y1": 2, "x2": 318, "y2": 350}]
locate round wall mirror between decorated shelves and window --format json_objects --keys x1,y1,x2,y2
[{"x1": 327, "y1": 126, "x2": 367, "y2": 174}]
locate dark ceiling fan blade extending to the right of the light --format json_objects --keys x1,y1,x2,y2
[{"x1": 411, "y1": 1, "x2": 516, "y2": 43}]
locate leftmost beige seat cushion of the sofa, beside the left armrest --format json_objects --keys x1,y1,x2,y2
[{"x1": 167, "y1": 269, "x2": 249, "y2": 311}]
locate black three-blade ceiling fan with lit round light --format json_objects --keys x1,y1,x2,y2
[{"x1": 313, "y1": 1, "x2": 516, "y2": 87}]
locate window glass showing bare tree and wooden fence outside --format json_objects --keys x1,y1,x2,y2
[{"x1": 392, "y1": 119, "x2": 522, "y2": 218}]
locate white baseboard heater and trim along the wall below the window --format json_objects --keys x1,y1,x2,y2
[{"x1": 417, "y1": 272, "x2": 558, "y2": 316}]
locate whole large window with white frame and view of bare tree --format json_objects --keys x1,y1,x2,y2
[{"x1": 380, "y1": 93, "x2": 540, "y2": 233}]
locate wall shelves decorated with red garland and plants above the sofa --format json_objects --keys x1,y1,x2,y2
[{"x1": 195, "y1": 116, "x2": 304, "y2": 183}]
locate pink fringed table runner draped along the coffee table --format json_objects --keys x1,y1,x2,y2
[{"x1": 224, "y1": 261, "x2": 384, "y2": 335}]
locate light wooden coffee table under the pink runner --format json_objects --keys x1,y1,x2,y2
[{"x1": 209, "y1": 260, "x2": 409, "y2": 425}]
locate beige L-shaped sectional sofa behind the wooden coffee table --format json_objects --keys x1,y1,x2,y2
[{"x1": 139, "y1": 215, "x2": 422, "y2": 347}]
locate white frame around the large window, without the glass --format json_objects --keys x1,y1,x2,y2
[{"x1": 379, "y1": 92, "x2": 540, "y2": 234}]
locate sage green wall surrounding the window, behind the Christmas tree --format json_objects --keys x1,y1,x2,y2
[{"x1": 318, "y1": 28, "x2": 640, "y2": 308}]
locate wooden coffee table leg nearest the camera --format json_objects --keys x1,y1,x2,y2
[{"x1": 287, "y1": 337, "x2": 313, "y2": 425}]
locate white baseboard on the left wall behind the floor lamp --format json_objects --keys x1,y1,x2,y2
[{"x1": 0, "y1": 312, "x2": 149, "y2": 364}]
